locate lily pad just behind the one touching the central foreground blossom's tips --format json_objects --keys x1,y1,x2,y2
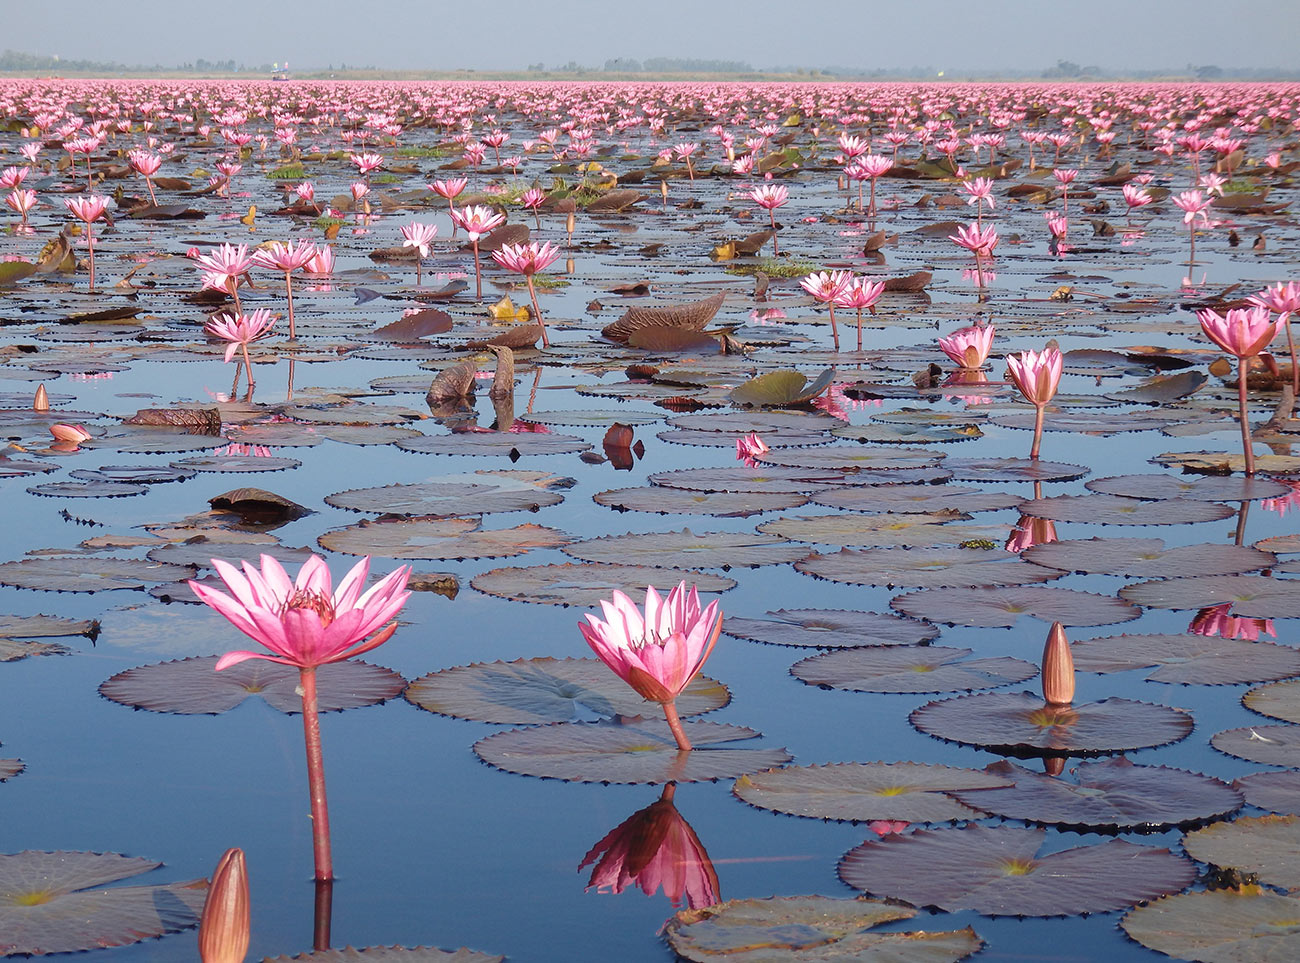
[{"x1": 563, "y1": 529, "x2": 809, "y2": 571}]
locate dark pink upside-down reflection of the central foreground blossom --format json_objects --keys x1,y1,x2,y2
[{"x1": 579, "y1": 782, "x2": 720, "y2": 910}]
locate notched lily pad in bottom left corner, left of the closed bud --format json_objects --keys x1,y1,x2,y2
[{"x1": 0, "y1": 850, "x2": 208, "y2": 957}]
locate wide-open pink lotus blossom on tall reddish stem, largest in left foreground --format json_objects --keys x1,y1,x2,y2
[{"x1": 190, "y1": 555, "x2": 411, "y2": 880}]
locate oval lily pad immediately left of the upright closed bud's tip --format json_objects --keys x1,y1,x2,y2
[{"x1": 790, "y1": 646, "x2": 1039, "y2": 691}]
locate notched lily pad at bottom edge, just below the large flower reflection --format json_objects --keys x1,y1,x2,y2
[{"x1": 664, "y1": 895, "x2": 984, "y2": 963}]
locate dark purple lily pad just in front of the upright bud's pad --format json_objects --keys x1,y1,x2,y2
[{"x1": 957, "y1": 756, "x2": 1242, "y2": 832}]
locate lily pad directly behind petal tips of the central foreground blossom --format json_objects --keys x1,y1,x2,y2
[{"x1": 469, "y1": 561, "x2": 736, "y2": 608}]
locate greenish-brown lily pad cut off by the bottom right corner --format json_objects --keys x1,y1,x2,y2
[{"x1": 1119, "y1": 886, "x2": 1300, "y2": 963}]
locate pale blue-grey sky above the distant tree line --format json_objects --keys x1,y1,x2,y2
[{"x1": 10, "y1": 0, "x2": 1300, "y2": 73}]
